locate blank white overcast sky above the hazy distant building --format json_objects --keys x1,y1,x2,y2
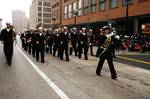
[{"x1": 0, "y1": 0, "x2": 32, "y2": 24}]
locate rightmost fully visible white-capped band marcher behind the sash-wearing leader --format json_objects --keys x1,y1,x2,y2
[{"x1": 78, "y1": 28, "x2": 88, "y2": 60}]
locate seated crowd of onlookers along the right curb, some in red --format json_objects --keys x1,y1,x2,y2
[{"x1": 115, "y1": 35, "x2": 150, "y2": 53}]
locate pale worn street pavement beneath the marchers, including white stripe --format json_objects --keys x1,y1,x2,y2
[{"x1": 0, "y1": 36, "x2": 150, "y2": 99}]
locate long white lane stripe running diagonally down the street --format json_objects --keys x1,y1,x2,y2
[{"x1": 17, "y1": 47, "x2": 69, "y2": 99}]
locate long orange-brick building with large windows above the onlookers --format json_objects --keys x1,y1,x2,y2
[{"x1": 62, "y1": 0, "x2": 150, "y2": 35}]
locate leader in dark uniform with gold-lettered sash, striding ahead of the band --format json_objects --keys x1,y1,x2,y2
[{"x1": 96, "y1": 26, "x2": 117, "y2": 80}]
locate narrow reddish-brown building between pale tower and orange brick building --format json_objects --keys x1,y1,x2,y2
[{"x1": 52, "y1": 0, "x2": 62, "y2": 28}]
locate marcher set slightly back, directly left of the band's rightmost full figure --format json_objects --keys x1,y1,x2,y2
[{"x1": 70, "y1": 28, "x2": 78, "y2": 56}]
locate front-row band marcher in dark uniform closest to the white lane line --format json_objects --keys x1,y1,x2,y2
[{"x1": 36, "y1": 27, "x2": 46, "y2": 63}]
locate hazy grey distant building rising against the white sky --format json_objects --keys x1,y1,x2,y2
[{"x1": 12, "y1": 10, "x2": 29, "y2": 33}]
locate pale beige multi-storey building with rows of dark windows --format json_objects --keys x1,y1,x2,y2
[{"x1": 30, "y1": 0, "x2": 52, "y2": 29}]
